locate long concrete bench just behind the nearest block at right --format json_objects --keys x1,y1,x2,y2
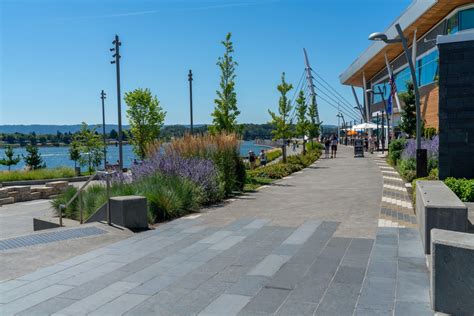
[{"x1": 416, "y1": 181, "x2": 467, "y2": 254}]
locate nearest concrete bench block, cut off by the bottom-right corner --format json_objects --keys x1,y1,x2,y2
[{"x1": 430, "y1": 229, "x2": 474, "y2": 315}]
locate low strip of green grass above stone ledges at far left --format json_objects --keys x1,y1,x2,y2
[{"x1": 0, "y1": 167, "x2": 75, "y2": 182}]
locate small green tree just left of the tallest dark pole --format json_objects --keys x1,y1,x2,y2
[{"x1": 72, "y1": 122, "x2": 104, "y2": 172}]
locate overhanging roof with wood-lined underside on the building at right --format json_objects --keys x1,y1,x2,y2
[{"x1": 339, "y1": 0, "x2": 472, "y2": 87}]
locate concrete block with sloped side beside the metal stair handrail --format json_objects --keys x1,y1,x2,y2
[{"x1": 86, "y1": 195, "x2": 148, "y2": 229}]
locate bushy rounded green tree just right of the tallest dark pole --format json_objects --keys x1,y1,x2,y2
[{"x1": 125, "y1": 89, "x2": 166, "y2": 159}]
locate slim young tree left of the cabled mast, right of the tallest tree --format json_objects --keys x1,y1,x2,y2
[{"x1": 268, "y1": 73, "x2": 293, "y2": 162}]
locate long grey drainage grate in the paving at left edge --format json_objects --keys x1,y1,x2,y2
[{"x1": 0, "y1": 227, "x2": 107, "y2": 251}]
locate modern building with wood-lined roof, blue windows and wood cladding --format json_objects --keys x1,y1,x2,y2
[{"x1": 340, "y1": 0, "x2": 474, "y2": 129}]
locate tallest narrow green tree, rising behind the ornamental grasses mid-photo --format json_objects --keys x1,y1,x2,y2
[{"x1": 209, "y1": 33, "x2": 240, "y2": 133}]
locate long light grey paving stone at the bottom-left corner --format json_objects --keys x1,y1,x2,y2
[{"x1": 0, "y1": 285, "x2": 71, "y2": 315}]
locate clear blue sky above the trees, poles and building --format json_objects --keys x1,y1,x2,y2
[{"x1": 0, "y1": 0, "x2": 411, "y2": 124}]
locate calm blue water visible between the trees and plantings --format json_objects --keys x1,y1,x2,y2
[{"x1": 0, "y1": 141, "x2": 268, "y2": 170}]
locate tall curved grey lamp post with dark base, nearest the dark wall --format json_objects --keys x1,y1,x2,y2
[{"x1": 369, "y1": 23, "x2": 428, "y2": 178}]
